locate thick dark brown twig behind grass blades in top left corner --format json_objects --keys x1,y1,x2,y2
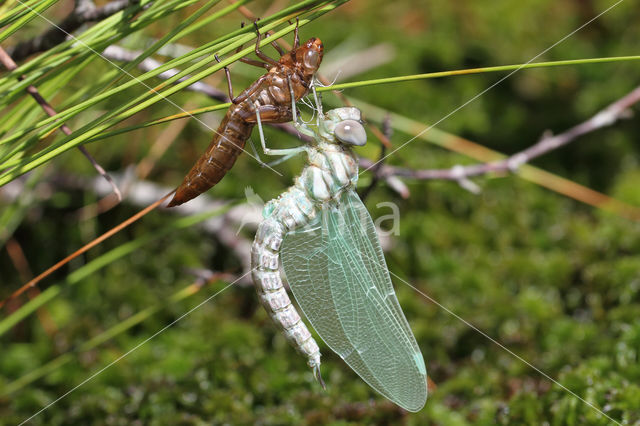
[{"x1": 7, "y1": 0, "x2": 138, "y2": 61}]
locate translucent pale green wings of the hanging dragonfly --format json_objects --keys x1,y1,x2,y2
[{"x1": 281, "y1": 191, "x2": 427, "y2": 411}]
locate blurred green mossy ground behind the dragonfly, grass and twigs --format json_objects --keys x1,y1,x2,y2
[{"x1": 0, "y1": 0, "x2": 640, "y2": 425}]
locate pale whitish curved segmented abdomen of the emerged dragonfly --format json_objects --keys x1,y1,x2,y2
[{"x1": 251, "y1": 187, "x2": 320, "y2": 370}]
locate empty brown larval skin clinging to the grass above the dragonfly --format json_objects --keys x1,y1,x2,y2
[{"x1": 168, "y1": 28, "x2": 323, "y2": 207}]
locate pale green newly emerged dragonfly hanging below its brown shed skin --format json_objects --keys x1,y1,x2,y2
[{"x1": 251, "y1": 91, "x2": 427, "y2": 412}]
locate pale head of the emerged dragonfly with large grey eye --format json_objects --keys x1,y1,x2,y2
[{"x1": 320, "y1": 107, "x2": 367, "y2": 146}]
